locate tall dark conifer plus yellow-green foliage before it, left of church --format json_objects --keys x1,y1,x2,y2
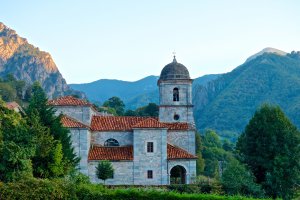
[{"x1": 26, "y1": 83, "x2": 79, "y2": 177}]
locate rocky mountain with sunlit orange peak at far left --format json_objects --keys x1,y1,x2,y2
[{"x1": 0, "y1": 22, "x2": 83, "y2": 98}]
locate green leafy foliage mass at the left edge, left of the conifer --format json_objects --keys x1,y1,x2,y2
[{"x1": 0, "y1": 101, "x2": 35, "y2": 181}]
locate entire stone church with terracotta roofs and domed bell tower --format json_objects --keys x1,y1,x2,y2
[{"x1": 49, "y1": 56, "x2": 197, "y2": 185}]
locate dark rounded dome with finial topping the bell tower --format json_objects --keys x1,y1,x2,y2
[{"x1": 159, "y1": 56, "x2": 190, "y2": 80}]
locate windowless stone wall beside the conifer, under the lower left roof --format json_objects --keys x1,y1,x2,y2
[{"x1": 70, "y1": 128, "x2": 91, "y2": 175}]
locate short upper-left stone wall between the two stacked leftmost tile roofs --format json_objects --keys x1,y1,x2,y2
[{"x1": 55, "y1": 106, "x2": 95, "y2": 125}]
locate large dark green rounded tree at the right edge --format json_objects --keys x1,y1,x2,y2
[{"x1": 237, "y1": 104, "x2": 300, "y2": 199}]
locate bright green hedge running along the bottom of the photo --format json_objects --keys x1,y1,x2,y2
[{"x1": 0, "y1": 179, "x2": 268, "y2": 200}]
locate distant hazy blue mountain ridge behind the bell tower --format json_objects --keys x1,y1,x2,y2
[{"x1": 70, "y1": 74, "x2": 219, "y2": 109}]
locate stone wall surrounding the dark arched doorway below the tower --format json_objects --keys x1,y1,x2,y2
[{"x1": 168, "y1": 159, "x2": 196, "y2": 184}]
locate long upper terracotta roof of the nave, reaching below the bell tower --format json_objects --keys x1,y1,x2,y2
[{"x1": 91, "y1": 116, "x2": 189, "y2": 131}]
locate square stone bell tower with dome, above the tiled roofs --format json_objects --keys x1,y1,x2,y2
[{"x1": 157, "y1": 55, "x2": 194, "y2": 125}]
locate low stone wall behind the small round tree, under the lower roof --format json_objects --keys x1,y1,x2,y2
[{"x1": 88, "y1": 161, "x2": 133, "y2": 185}]
